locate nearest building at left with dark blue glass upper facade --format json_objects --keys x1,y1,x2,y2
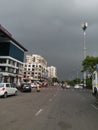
[{"x1": 0, "y1": 25, "x2": 27, "y2": 83}]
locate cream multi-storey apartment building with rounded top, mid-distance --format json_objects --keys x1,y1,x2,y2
[{"x1": 24, "y1": 54, "x2": 47, "y2": 81}]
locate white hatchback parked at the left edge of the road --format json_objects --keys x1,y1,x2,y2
[{"x1": 0, "y1": 83, "x2": 18, "y2": 98}]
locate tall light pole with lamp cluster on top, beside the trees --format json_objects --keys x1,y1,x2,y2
[{"x1": 82, "y1": 22, "x2": 88, "y2": 87}]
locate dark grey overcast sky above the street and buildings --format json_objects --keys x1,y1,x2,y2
[{"x1": 0, "y1": 0, "x2": 98, "y2": 80}]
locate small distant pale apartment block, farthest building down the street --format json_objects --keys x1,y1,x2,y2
[{"x1": 47, "y1": 66, "x2": 57, "y2": 78}]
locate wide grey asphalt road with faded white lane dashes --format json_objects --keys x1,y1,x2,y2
[{"x1": 0, "y1": 87, "x2": 98, "y2": 130}]
